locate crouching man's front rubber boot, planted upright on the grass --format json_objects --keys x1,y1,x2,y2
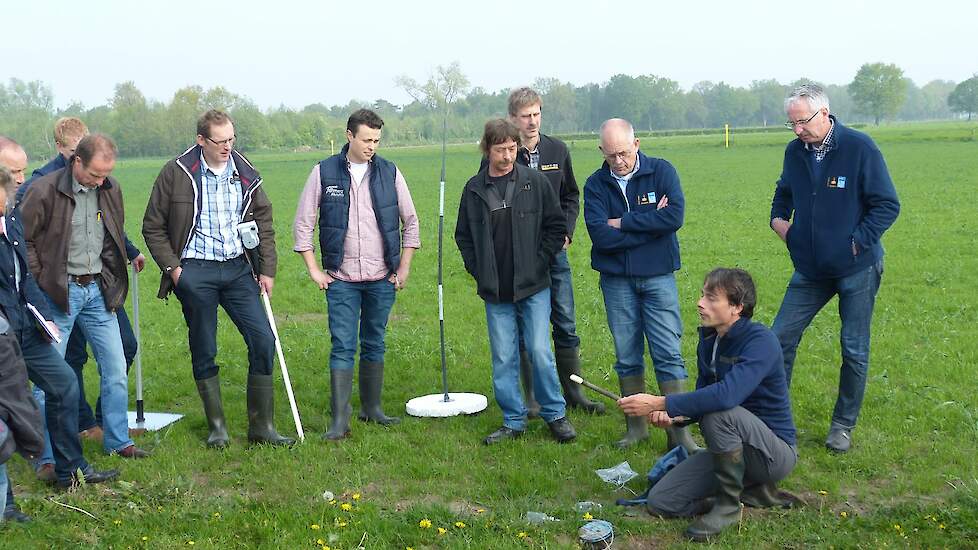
[{"x1": 686, "y1": 448, "x2": 744, "y2": 542}]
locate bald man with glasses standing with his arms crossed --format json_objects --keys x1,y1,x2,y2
[{"x1": 584, "y1": 118, "x2": 699, "y2": 451}]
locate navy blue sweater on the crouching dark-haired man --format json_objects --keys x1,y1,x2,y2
[{"x1": 666, "y1": 319, "x2": 797, "y2": 445}]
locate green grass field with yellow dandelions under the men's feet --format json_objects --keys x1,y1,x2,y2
[{"x1": 0, "y1": 124, "x2": 978, "y2": 549}]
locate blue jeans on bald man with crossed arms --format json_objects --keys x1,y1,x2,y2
[{"x1": 601, "y1": 273, "x2": 686, "y2": 382}]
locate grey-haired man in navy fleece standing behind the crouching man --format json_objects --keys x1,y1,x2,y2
[{"x1": 771, "y1": 84, "x2": 900, "y2": 453}]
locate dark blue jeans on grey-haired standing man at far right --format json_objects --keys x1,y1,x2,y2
[{"x1": 771, "y1": 259, "x2": 883, "y2": 429}]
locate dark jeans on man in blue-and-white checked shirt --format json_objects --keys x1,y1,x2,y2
[{"x1": 174, "y1": 256, "x2": 275, "y2": 380}]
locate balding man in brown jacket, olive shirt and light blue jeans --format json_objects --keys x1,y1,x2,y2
[{"x1": 21, "y1": 134, "x2": 149, "y2": 458}]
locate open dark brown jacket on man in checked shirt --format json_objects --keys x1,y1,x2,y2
[{"x1": 143, "y1": 145, "x2": 278, "y2": 298}]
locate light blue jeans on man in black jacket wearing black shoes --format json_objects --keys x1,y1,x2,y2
[{"x1": 486, "y1": 288, "x2": 566, "y2": 430}]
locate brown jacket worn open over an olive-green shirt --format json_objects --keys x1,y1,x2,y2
[{"x1": 20, "y1": 165, "x2": 129, "y2": 312}]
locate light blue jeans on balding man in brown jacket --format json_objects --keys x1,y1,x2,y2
[{"x1": 52, "y1": 281, "x2": 133, "y2": 453}]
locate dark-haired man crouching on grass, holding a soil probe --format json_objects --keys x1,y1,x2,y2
[{"x1": 618, "y1": 268, "x2": 798, "y2": 541}]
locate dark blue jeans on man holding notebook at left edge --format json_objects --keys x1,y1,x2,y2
[{"x1": 17, "y1": 326, "x2": 88, "y2": 480}]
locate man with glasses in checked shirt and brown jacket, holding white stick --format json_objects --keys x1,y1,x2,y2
[{"x1": 143, "y1": 110, "x2": 294, "y2": 448}]
